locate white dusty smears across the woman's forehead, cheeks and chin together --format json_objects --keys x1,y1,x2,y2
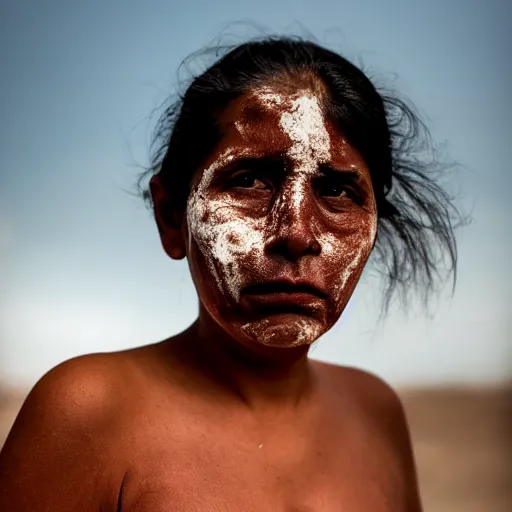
[{"x1": 187, "y1": 90, "x2": 373, "y2": 346}]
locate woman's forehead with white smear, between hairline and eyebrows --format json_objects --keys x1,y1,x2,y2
[{"x1": 214, "y1": 87, "x2": 366, "y2": 168}]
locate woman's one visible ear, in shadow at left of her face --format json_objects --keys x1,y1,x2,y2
[{"x1": 149, "y1": 174, "x2": 187, "y2": 260}]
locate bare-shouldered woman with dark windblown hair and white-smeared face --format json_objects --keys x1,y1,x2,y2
[{"x1": 0, "y1": 38, "x2": 457, "y2": 512}]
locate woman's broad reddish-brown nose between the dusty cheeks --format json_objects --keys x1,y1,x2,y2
[{"x1": 266, "y1": 195, "x2": 321, "y2": 262}]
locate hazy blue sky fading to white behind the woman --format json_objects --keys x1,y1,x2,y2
[{"x1": 0, "y1": 0, "x2": 512, "y2": 384}]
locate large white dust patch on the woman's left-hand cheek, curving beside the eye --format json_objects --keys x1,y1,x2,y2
[{"x1": 186, "y1": 150, "x2": 264, "y2": 301}]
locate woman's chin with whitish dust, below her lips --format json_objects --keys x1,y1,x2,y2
[{"x1": 242, "y1": 315, "x2": 327, "y2": 348}]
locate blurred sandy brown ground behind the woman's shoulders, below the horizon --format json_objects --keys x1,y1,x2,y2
[{"x1": 0, "y1": 386, "x2": 512, "y2": 512}]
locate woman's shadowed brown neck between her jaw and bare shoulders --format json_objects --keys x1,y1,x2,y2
[{"x1": 179, "y1": 308, "x2": 315, "y2": 411}]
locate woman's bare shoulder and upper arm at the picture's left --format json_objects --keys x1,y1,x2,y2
[{"x1": 0, "y1": 356, "x2": 124, "y2": 512}]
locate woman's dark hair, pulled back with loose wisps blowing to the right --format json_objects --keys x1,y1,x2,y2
[{"x1": 138, "y1": 36, "x2": 463, "y2": 311}]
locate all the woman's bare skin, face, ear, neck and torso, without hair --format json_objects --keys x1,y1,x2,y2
[{"x1": 0, "y1": 89, "x2": 420, "y2": 512}]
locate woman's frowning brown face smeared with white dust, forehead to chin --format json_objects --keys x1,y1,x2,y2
[{"x1": 183, "y1": 87, "x2": 377, "y2": 347}]
